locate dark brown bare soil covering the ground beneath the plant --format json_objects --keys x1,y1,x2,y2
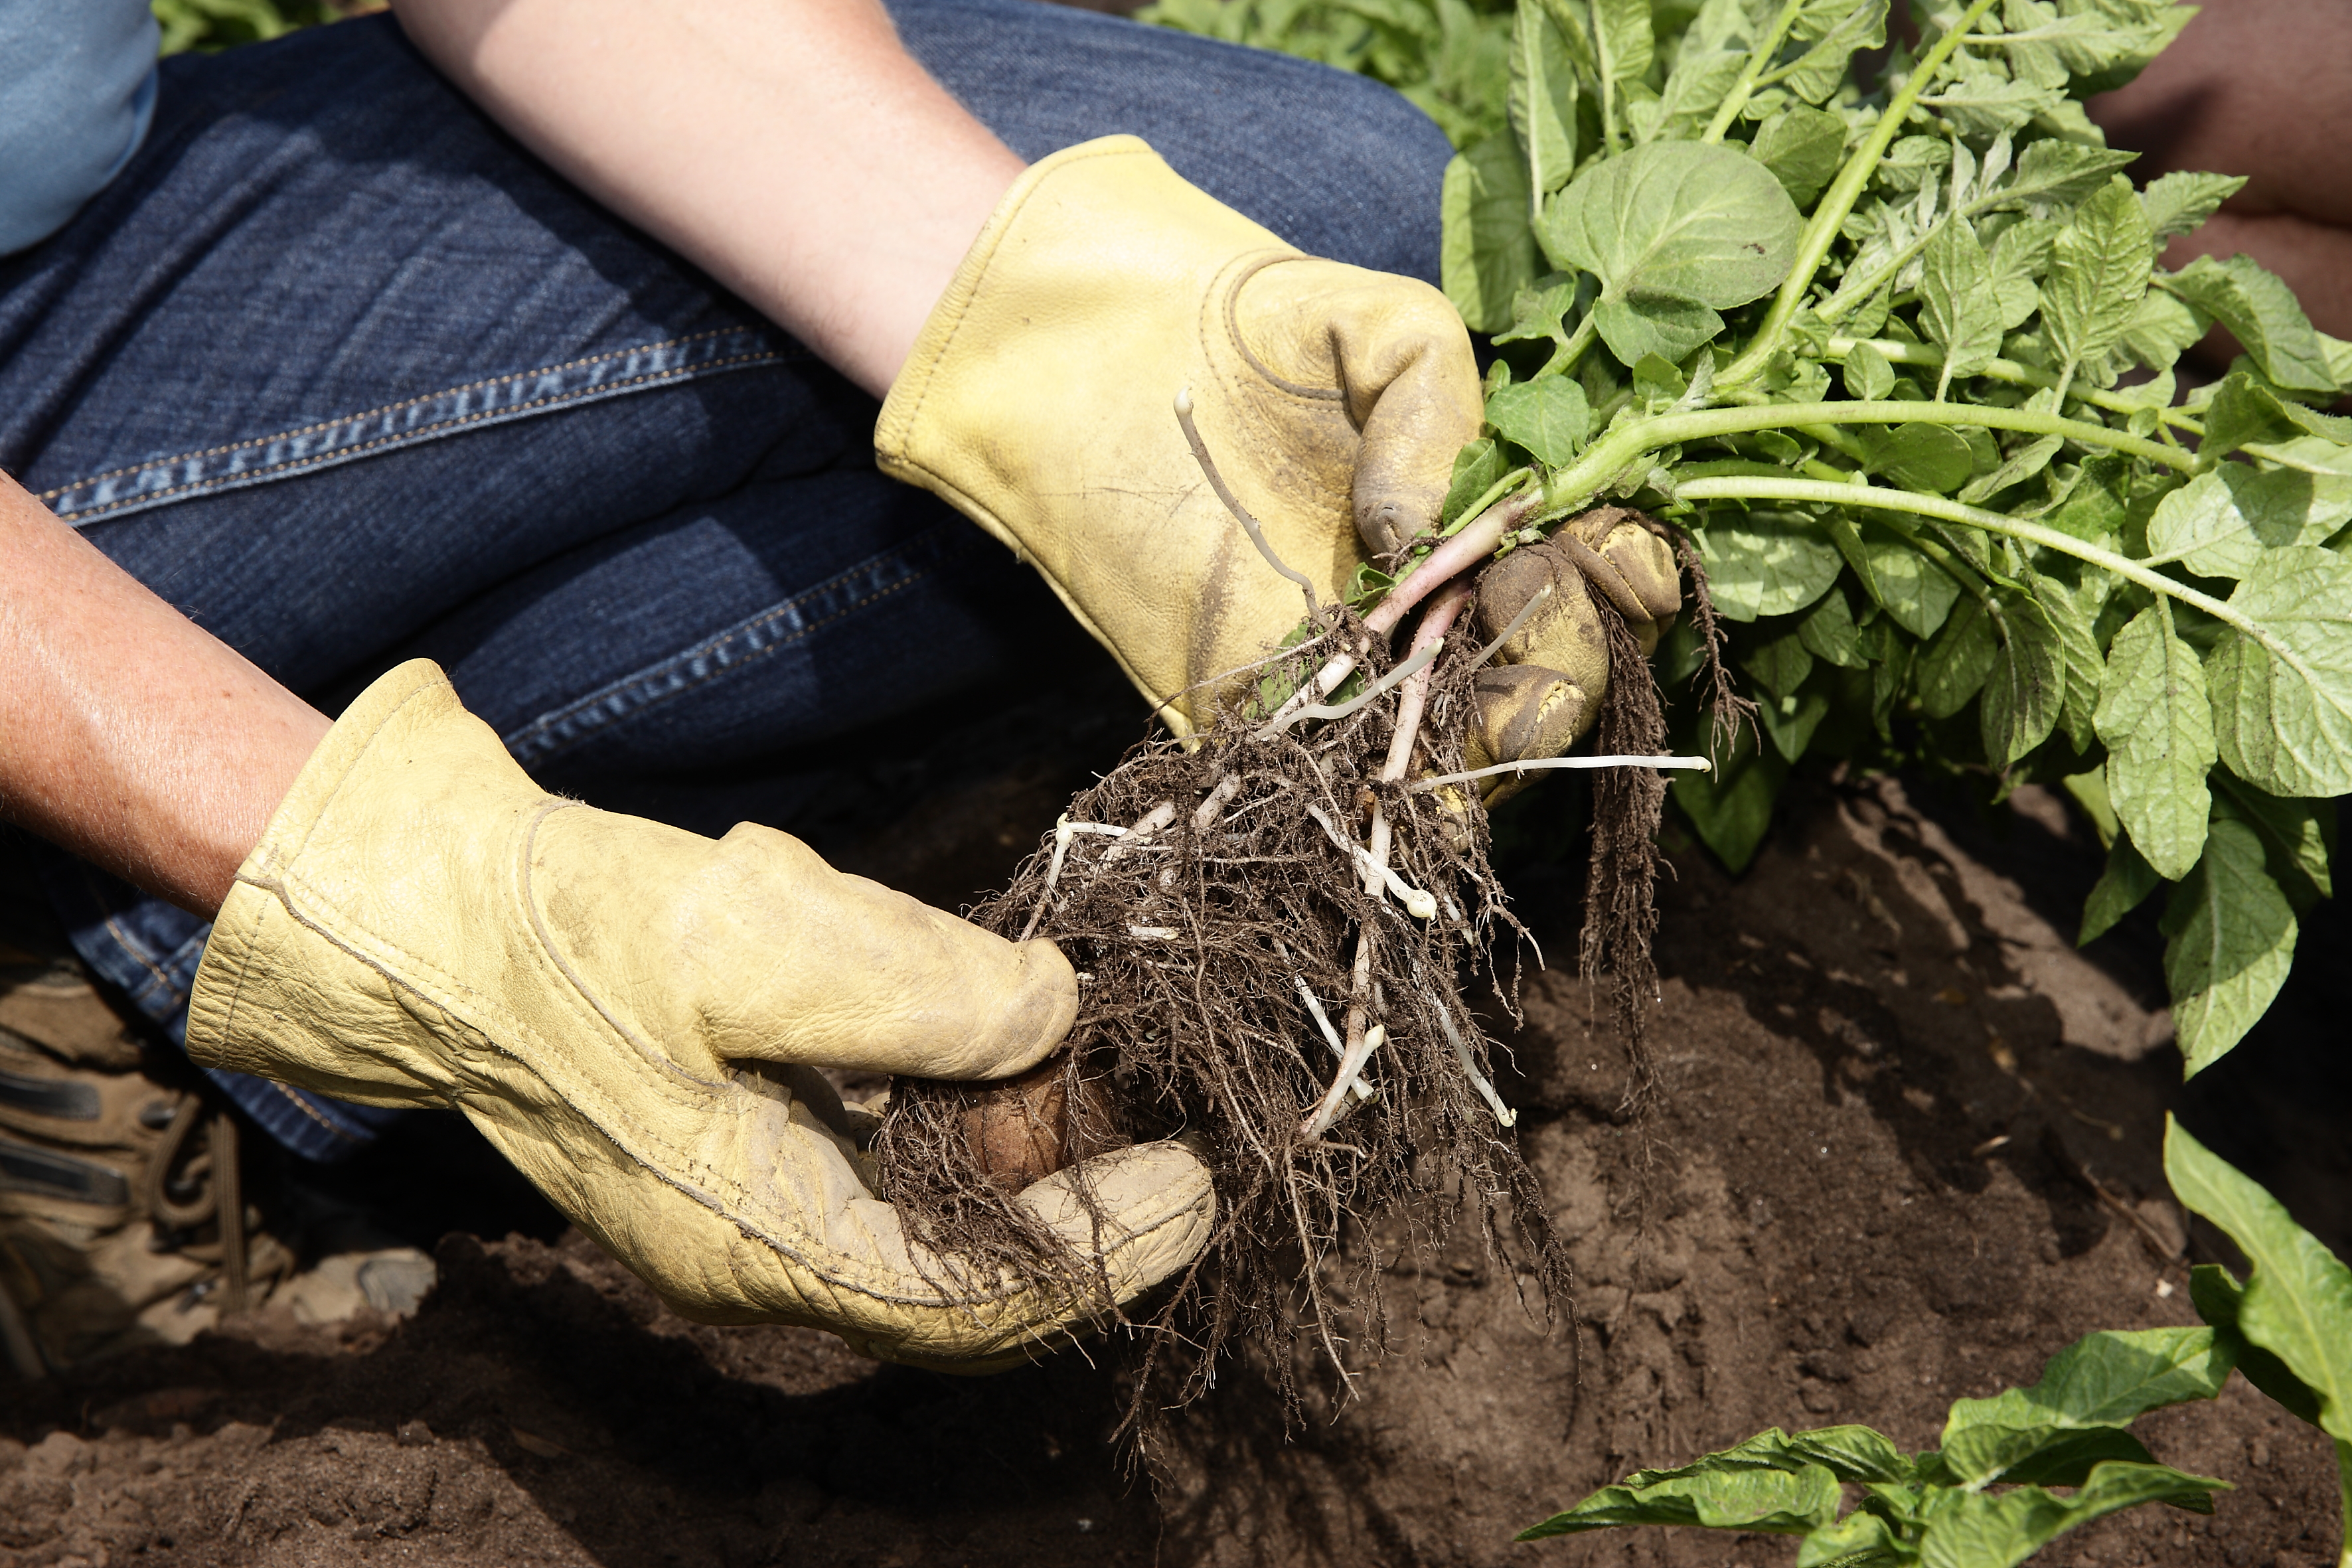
[{"x1": 0, "y1": 681, "x2": 2352, "y2": 1568}]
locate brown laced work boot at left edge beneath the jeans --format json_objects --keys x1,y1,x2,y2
[{"x1": 0, "y1": 921, "x2": 294, "y2": 1377}]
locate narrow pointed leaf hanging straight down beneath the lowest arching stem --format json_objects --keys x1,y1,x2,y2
[{"x1": 2091, "y1": 602, "x2": 2218, "y2": 882}]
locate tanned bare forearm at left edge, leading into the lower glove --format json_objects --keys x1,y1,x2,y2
[{"x1": 0, "y1": 477, "x2": 327, "y2": 919}]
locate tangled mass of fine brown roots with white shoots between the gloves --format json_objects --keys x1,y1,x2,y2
[{"x1": 872, "y1": 597, "x2": 1567, "y2": 1439}]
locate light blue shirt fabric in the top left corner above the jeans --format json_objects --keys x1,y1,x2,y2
[{"x1": 0, "y1": 0, "x2": 157, "y2": 256}]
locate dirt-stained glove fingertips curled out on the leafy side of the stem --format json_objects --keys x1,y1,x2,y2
[{"x1": 1463, "y1": 505, "x2": 1682, "y2": 802}]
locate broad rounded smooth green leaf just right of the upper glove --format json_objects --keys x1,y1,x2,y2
[{"x1": 1538, "y1": 138, "x2": 1802, "y2": 364}]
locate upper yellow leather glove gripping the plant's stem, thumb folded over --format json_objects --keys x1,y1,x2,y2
[{"x1": 875, "y1": 136, "x2": 1482, "y2": 736}]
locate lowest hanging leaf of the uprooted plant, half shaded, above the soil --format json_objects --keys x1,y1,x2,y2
[{"x1": 2161, "y1": 818, "x2": 2296, "y2": 1077}]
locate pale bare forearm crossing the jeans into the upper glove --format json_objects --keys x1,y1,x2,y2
[{"x1": 393, "y1": 0, "x2": 1021, "y2": 395}]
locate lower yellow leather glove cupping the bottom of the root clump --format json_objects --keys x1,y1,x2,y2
[{"x1": 188, "y1": 661, "x2": 1214, "y2": 1371}]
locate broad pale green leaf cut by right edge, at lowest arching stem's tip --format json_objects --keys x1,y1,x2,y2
[{"x1": 2206, "y1": 546, "x2": 2352, "y2": 795}]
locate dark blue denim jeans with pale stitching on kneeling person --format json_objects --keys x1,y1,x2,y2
[{"x1": 0, "y1": 0, "x2": 1449, "y2": 1159}]
